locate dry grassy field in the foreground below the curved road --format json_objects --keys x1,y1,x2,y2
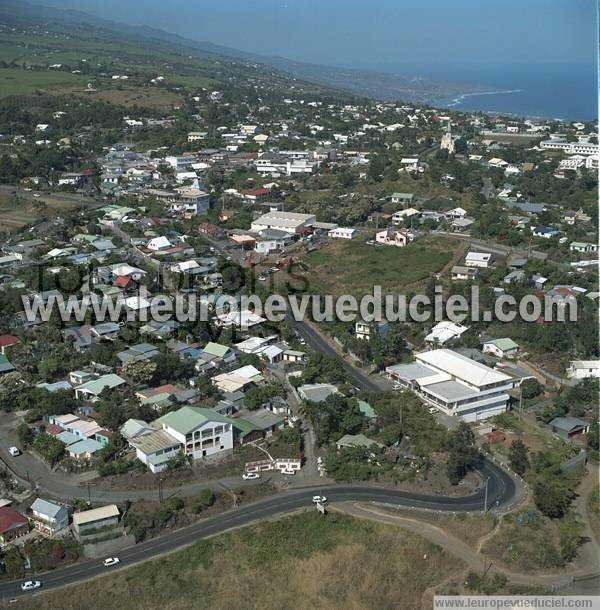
[{"x1": 28, "y1": 512, "x2": 463, "y2": 610}]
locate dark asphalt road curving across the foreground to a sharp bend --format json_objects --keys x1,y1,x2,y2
[{"x1": 0, "y1": 461, "x2": 516, "y2": 600}]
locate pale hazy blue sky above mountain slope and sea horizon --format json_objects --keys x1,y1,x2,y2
[{"x1": 35, "y1": 0, "x2": 597, "y2": 69}]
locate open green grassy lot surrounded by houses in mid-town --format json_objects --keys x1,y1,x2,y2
[{"x1": 303, "y1": 236, "x2": 459, "y2": 297}]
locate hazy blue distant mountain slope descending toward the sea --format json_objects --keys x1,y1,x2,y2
[{"x1": 0, "y1": 0, "x2": 486, "y2": 103}]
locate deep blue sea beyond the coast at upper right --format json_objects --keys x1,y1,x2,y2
[{"x1": 354, "y1": 61, "x2": 598, "y2": 121}]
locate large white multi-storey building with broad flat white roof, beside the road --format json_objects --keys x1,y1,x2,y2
[{"x1": 386, "y1": 349, "x2": 518, "y2": 422}]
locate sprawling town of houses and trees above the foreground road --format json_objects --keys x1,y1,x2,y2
[{"x1": 0, "y1": 7, "x2": 600, "y2": 600}]
